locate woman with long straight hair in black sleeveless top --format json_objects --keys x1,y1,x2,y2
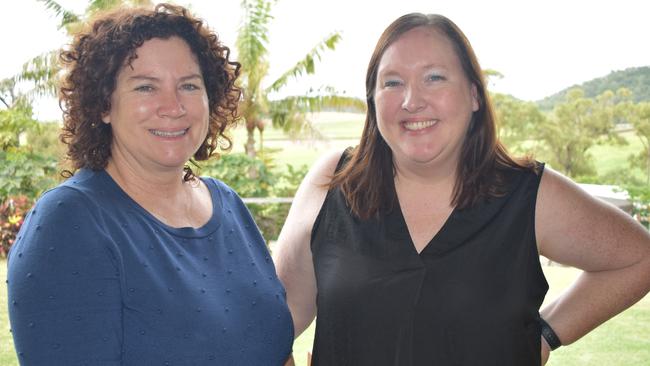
[{"x1": 274, "y1": 13, "x2": 650, "y2": 366}]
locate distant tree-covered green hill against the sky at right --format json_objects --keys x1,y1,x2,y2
[{"x1": 537, "y1": 66, "x2": 650, "y2": 111}]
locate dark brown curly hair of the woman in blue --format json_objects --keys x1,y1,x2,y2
[{"x1": 59, "y1": 4, "x2": 241, "y2": 181}]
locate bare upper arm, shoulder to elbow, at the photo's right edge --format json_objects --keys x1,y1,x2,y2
[{"x1": 535, "y1": 167, "x2": 649, "y2": 270}]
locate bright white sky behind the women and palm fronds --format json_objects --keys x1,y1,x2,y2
[{"x1": 0, "y1": 0, "x2": 650, "y2": 119}]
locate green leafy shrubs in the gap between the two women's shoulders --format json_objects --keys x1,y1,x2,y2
[{"x1": 201, "y1": 153, "x2": 307, "y2": 242}]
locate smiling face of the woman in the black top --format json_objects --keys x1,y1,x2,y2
[{"x1": 374, "y1": 27, "x2": 479, "y2": 170}]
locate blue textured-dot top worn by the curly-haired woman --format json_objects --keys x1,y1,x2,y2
[{"x1": 7, "y1": 170, "x2": 293, "y2": 366}]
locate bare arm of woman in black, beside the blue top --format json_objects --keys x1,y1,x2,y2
[{"x1": 273, "y1": 151, "x2": 342, "y2": 337}]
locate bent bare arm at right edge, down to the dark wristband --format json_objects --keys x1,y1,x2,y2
[{"x1": 535, "y1": 169, "x2": 650, "y2": 344}]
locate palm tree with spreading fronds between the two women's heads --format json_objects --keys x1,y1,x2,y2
[{"x1": 236, "y1": 0, "x2": 365, "y2": 156}]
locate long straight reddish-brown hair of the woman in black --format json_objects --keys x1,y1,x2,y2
[{"x1": 330, "y1": 13, "x2": 535, "y2": 219}]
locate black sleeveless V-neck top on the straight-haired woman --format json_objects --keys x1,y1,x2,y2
[{"x1": 311, "y1": 153, "x2": 548, "y2": 366}]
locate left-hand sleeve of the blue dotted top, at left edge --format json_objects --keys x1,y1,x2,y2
[{"x1": 7, "y1": 187, "x2": 122, "y2": 365}]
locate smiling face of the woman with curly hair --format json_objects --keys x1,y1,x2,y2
[{"x1": 102, "y1": 37, "x2": 210, "y2": 171}]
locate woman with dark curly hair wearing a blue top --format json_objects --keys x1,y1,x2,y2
[{"x1": 8, "y1": 4, "x2": 293, "y2": 365}]
